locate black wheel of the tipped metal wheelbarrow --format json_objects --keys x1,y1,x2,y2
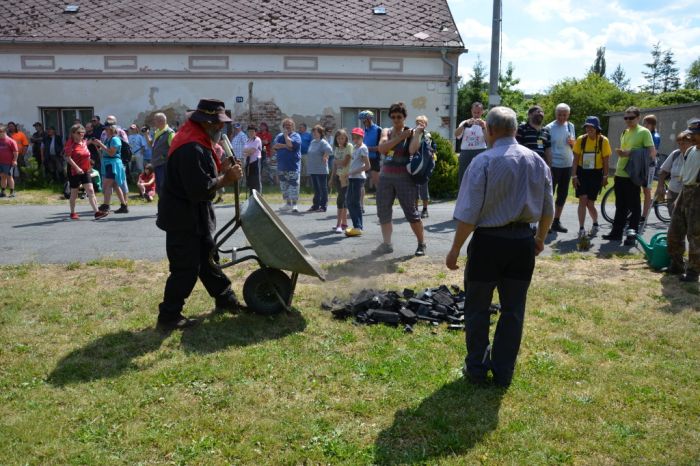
[{"x1": 243, "y1": 269, "x2": 292, "y2": 315}]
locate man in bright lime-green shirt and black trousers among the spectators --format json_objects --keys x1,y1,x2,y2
[{"x1": 603, "y1": 107, "x2": 656, "y2": 246}]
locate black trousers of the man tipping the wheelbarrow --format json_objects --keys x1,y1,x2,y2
[{"x1": 159, "y1": 232, "x2": 231, "y2": 320}]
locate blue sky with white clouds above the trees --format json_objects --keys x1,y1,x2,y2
[{"x1": 447, "y1": 0, "x2": 700, "y2": 94}]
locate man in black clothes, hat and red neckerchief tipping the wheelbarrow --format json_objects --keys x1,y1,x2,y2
[{"x1": 156, "y1": 99, "x2": 242, "y2": 330}]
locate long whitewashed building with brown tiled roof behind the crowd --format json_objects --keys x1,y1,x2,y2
[{"x1": 0, "y1": 0, "x2": 466, "y2": 140}]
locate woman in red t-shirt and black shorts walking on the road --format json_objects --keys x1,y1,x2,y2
[{"x1": 64, "y1": 124, "x2": 108, "y2": 220}]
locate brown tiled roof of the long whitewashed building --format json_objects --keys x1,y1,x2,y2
[{"x1": 0, "y1": 0, "x2": 464, "y2": 48}]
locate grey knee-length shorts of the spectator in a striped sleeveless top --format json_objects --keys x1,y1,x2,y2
[{"x1": 377, "y1": 172, "x2": 421, "y2": 225}]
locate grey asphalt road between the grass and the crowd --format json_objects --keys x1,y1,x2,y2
[{"x1": 0, "y1": 197, "x2": 666, "y2": 264}]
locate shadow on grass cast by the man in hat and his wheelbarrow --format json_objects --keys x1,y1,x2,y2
[{"x1": 47, "y1": 312, "x2": 306, "y2": 386}]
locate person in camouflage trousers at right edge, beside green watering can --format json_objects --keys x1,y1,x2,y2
[{"x1": 668, "y1": 118, "x2": 700, "y2": 283}]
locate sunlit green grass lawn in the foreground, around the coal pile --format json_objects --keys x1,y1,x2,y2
[{"x1": 0, "y1": 254, "x2": 700, "y2": 465}]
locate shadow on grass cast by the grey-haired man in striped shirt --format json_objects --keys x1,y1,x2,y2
[{"x1": 374, "y1": 378, "x2": 506, "y2": 464}]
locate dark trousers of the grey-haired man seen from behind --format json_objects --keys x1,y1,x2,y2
[{"x1": 464, "y1": 229, "x2": 535, "y2": 385}]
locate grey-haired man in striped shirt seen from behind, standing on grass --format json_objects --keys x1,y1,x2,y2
[{"x1": 445, "y1": 107, "x2": 554, "y2": 387}]
